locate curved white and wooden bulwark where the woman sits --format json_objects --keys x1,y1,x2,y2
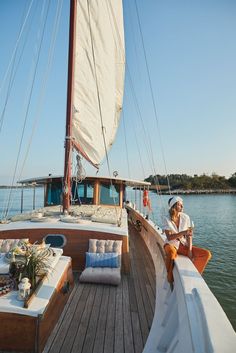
[{"x1": 129, "y1": 208, "x2": 236, "y2": 353}]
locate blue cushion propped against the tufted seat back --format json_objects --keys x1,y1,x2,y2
[{"x1": 86, "y1": 252, "x2": 119, "y2": 268}]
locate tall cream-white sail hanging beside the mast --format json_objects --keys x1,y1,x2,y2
[{"x1": 72, "y1": 0, "x2": 125, "y2": 166}]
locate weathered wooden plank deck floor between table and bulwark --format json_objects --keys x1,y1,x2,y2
[{"x1": 43, "y1": 227, "x2": 156, "y2": 353}]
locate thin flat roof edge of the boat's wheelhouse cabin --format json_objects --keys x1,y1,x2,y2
[{"x1": 18, "y1": 175, "x2": 151, "y2": 186}]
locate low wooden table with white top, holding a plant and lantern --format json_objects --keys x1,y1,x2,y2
[{"x1": 0, "y1": 256, "x2": 74, "y2": 353}]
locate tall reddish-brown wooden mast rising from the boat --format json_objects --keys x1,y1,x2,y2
[{"x1": 63, "y1": 0, "x2": 77, "y2": 212}]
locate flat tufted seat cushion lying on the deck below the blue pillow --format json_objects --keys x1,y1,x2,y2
[{"x1": 80, "y1": 267, "x2": 121, "y2": 286}]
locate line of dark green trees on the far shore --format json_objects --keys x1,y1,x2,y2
[{"x1": 145, "y1": 172, "x2": 236, "y2": 190}]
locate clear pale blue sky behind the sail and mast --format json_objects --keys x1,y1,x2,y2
[{"x1": 0, "y1": 0, "x2": 236, "y2": 185}]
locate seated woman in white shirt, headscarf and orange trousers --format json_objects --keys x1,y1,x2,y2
[{"x1": 163, "y1": 196, "x2": 211, "y2": 283}]
